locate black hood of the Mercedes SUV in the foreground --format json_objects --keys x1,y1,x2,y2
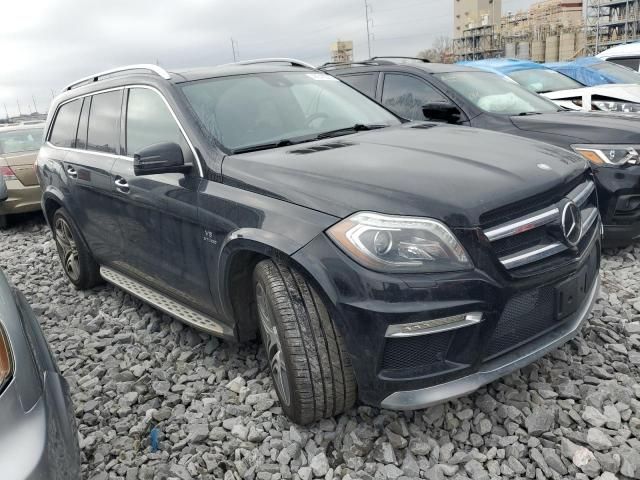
[{"x1": 222, "y1": 123, "x2": 587, "y2": 227}]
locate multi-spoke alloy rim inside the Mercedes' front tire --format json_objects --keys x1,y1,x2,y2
[{"x1": 256, "y1": 283, "x2": 291, "y2": 405}]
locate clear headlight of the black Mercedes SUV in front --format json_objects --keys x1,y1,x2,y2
[{"x1": 327, "y1": 212, "x2": 473, "y2": 273}]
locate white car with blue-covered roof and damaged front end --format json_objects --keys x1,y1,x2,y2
[{"x1": 461, "y1": 58, "x2": 640, "y2": 112}]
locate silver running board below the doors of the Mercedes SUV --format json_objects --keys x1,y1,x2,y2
[{"x1": 100, "y1": 267, "x2": 233, "y2": 337}]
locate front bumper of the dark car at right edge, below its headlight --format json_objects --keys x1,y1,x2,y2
[{"x1": 594, "y1": 165, "x2": 640, "y2": 247}]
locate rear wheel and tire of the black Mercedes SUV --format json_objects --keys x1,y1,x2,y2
[{"x1": 52, "y1": 208, "x2": 101, "y2": 290}]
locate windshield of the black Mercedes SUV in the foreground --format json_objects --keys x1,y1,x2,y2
[{"x1": 182, "y1": 72, "x2": 400, "y2": 151}]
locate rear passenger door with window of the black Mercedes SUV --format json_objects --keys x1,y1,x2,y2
[{"x1": 64, "y1": 89, "x2": 123, "y2": 263}]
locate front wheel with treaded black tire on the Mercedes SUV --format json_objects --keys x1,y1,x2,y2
[{"x1": 253, "y1": 260, "x2": 356, "y2": 425}]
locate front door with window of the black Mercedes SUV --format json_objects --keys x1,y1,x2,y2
[{"x1": 111, "y1": 86, "x2": 213, "y2": 313}]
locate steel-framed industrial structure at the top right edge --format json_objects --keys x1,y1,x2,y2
[{"x1": 586, "y1": 0, "x2": 640, "y2": 55}]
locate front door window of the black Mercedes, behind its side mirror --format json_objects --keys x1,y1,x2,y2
[{"x1": 127, "y1": 88, "x2": 187, "y2": 155}]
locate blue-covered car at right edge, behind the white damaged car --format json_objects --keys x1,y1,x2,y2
[{"x1": 544, "y1": 57, "x2": 640, "y2": 87}]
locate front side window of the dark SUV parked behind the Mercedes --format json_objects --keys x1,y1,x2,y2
[{"x1": 382, "y1": 74, "x2": 446, "y2": 120}]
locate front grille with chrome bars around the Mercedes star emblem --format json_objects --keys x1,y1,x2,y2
[{"x1": 484, "y1": 177, "x2": 599, "y2": 271}]
